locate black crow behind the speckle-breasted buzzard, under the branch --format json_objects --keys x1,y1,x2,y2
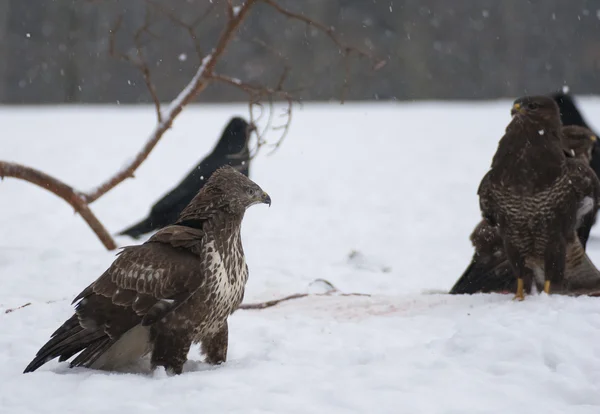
[{"x1": 119, "y1": 117, "x2": 254, "y2": 239}]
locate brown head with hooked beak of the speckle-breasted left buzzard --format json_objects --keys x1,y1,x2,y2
[{"x1": 205, "y1": 165, "x2": 271, "y2": 213}]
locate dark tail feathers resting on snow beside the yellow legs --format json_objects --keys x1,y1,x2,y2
[{"x1": 449, "y1": 256, "x2": 516, "y2": 295}]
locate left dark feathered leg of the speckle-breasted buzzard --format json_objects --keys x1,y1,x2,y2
[{"x1": 150, "y1": 331, "x2": 192, "y2": 374}]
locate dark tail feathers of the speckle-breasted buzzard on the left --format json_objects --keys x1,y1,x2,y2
[{"x1": 23, "y1": 315, "x2": 106, "y2": 373}]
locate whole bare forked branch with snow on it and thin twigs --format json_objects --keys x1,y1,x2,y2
[{"x1": 0, "y1": 0, "x2": 385, "y2": 251}]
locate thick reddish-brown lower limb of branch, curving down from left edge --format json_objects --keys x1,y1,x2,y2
[{"x1": 0, "y1": 161, "x2": 117, "y2": 250}]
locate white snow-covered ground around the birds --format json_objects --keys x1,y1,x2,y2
[{"x1": 0, "y1": 99, "x2": 600, "y2": 414}]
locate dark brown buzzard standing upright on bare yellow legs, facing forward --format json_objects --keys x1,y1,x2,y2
[{"x1": 478, "y1": 96, "x2": 600, "y2": 300}]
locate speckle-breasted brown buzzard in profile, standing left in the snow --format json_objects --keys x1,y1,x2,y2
[{"x1": 25, "y1": 166, "x2": 271, "y2": 374}]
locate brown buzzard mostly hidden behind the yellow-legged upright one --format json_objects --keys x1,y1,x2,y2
[{"x1": 449, "y1": 126, "x2": 600, "y2": 294}]
